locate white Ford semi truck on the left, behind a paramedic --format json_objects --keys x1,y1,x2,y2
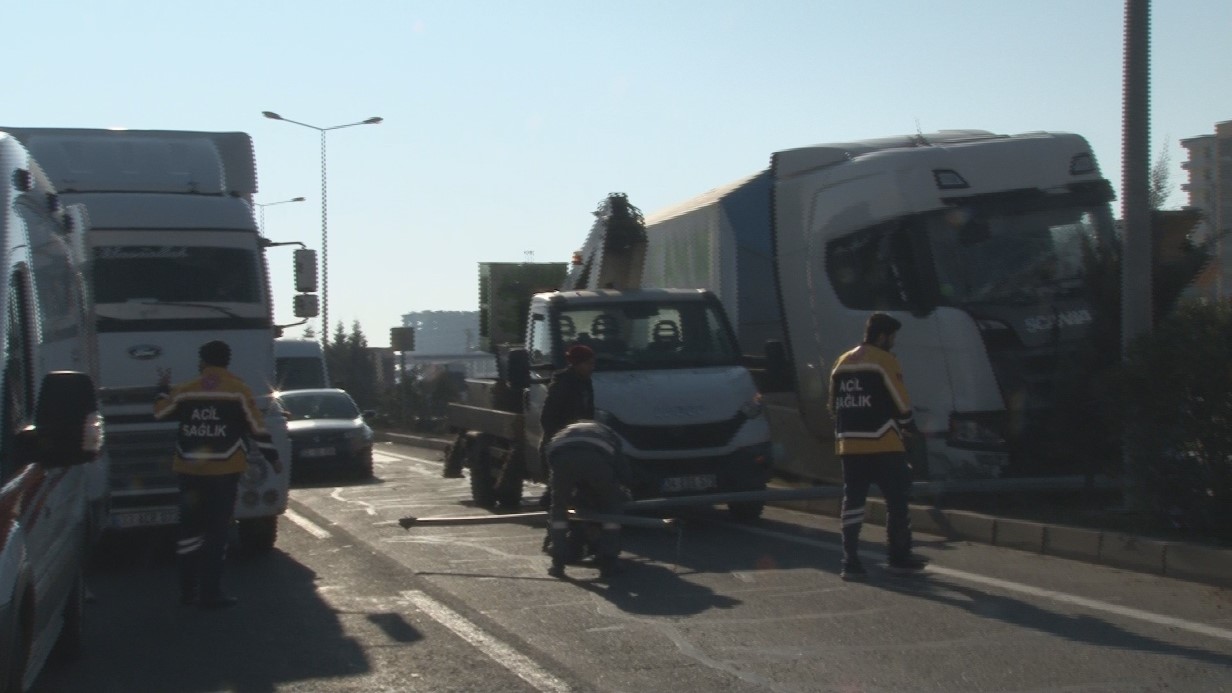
[{"x1": 2, "y1": 128, "x2": 305, "y2": 550}]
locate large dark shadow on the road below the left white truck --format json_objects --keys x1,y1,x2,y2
[{"x1": 34, "y1": 525, "x2": 371, "y2": 693}]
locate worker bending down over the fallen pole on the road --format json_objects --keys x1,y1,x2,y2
[{"x1": 545, "y1": 422, "x2": 630, "y2": 580}]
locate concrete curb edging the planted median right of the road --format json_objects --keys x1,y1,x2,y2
[{"x1": 377, "y1": 432, "x2": 1232, "y2": 588}]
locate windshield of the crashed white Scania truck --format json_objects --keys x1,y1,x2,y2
[{"x1": 924, "y1": 205, "x2": 1112, "y2": 306}]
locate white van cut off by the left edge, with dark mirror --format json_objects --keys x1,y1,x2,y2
[{"x1": 0, "y1": 132, "x2": 102, "y2": 691}]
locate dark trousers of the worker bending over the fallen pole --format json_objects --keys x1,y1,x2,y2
[{"x1": 548, "y1": 445, "x2": 628, "y2": 562}]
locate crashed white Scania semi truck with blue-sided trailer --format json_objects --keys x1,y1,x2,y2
[{"x1": 641, "y1": 131, "x2": 1114, "y2": 481}]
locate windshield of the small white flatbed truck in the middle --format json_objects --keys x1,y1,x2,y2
[{"x1": 556, "y1": 301, "x2": 739, "y2": 370}]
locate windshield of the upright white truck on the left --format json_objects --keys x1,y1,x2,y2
[{"x1": 94, "y1": 245, "x2": 261, "y2": 303}]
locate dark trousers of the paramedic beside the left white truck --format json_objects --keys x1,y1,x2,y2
[{"x1": 175, "y1": 474, "x2": 239, "y2": 601}]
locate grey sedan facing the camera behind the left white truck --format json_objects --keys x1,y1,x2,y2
[{"x1": 277, "y1": 390, "x2": 372, "y2": 478}]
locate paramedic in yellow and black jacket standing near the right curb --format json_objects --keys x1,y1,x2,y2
[{"x1": 829, "y1": 312, "x2": 924, "y2": 581}]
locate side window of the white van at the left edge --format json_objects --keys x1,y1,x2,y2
[{"x1": 0, "y1": 268, "x2": 34, "y2": 481}]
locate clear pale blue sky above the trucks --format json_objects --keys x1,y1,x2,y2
[{"x1": 0, "y1": 0, "x2": 1232, "y2": 347}]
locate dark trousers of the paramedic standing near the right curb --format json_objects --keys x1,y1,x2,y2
[{"x1": 843, "y1": 453, "x2": 912, "y2": 564}]
